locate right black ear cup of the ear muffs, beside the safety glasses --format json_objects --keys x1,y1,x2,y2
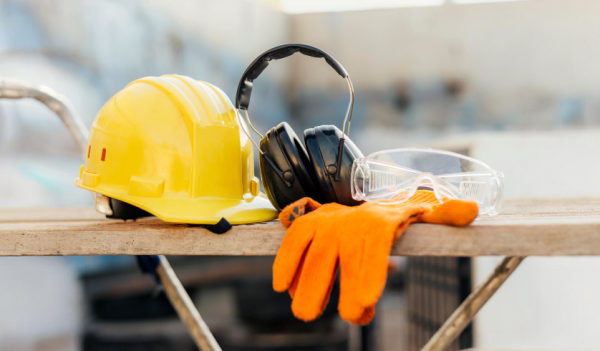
[{"x1": 304, "y1": 125, "x2": 363, "y2": 206}]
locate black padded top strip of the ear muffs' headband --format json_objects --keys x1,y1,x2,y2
[{"x1": 235, "y1": 44, "x2": 348, "y2": 110}]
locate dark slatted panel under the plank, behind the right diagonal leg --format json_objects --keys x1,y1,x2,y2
[{"x1": 406, "y1": 257, "x2": 473, "y2": 351}]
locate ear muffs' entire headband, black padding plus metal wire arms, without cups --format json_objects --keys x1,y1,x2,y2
[{"x1": 235, "y1": 44, "x2": 354, "y2": 187}]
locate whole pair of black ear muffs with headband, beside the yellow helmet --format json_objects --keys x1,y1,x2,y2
[{"x1": 235, "y1": 44, "x2": 362, "y2": 210}]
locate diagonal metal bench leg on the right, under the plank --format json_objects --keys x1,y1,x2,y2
[{"x1": 421, "y1": 257, "x2": 525, "y2": 351}]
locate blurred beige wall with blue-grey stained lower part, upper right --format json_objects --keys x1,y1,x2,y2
[{"x1": 292, "y1": 0, "x2": 600, "y2": 133}]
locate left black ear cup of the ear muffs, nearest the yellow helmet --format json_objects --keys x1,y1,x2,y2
[{"x1": 260, "y1": 122, "x2": 320, "y2": 210}]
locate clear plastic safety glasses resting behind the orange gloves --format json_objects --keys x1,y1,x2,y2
[{"x1": 351, "y1": 149, "x2": 504, "y2": 216}]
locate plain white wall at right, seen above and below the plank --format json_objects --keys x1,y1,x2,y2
[{"x1": 431, "y1": 129, "x2": 600, "y2": 351}]
